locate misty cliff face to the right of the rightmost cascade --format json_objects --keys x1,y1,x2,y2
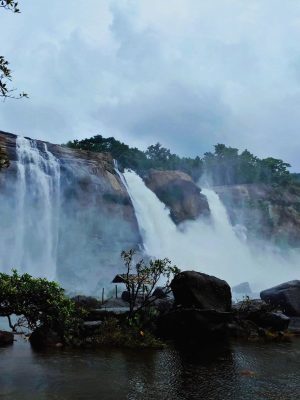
[{"x1": 214, "y1": 184, "x2": 300, "y2": 247}]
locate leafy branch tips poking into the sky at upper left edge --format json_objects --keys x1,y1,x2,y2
[{"x1": 0, "y1": 0, "x2": 28, "y2": 99}]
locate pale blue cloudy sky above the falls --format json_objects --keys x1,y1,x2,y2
[{"x1": 0, "y1": 0, "x2": 300, "y2": 171}]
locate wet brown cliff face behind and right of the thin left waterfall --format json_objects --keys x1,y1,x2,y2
[{"x1": 0, "y1": 132, "x2": 141, "y2": 292}]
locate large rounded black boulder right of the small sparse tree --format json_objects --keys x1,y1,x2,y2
[{"x1": 171, "y1": 271, "x2": 231, "y2": 312}]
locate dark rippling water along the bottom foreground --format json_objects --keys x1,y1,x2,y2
[{"x1": 0, "y1": 341, "x2": 300, "y2": 400}]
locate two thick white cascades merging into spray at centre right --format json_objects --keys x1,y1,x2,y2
[{"x1": 124, "y1": 171, "x2": 300, "y2": 291}]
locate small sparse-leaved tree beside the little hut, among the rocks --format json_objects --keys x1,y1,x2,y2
[{"x1": 121, "y1": 250, "x2": 180, "y2": 316}]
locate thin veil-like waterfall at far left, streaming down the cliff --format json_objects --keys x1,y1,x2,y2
[{"x1": 0, "y1": 137, "x2": 60, "y2": 279}]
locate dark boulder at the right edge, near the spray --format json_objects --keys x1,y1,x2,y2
[{"x1": 260, "y1": 280, "x2": 300, "y2": 317}]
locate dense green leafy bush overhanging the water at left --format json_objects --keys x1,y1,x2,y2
[{"x1": 0, "y1": 270, "x2": 80, "y2": 337}]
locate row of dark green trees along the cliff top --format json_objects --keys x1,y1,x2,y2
[{"x1": 67, "y1": 135, "x2": 299, "y2": 185}]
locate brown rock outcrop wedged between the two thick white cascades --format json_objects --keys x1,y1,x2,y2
[{"x1": 144, "y1": 169, "x2": 209, "y2": 224}]
